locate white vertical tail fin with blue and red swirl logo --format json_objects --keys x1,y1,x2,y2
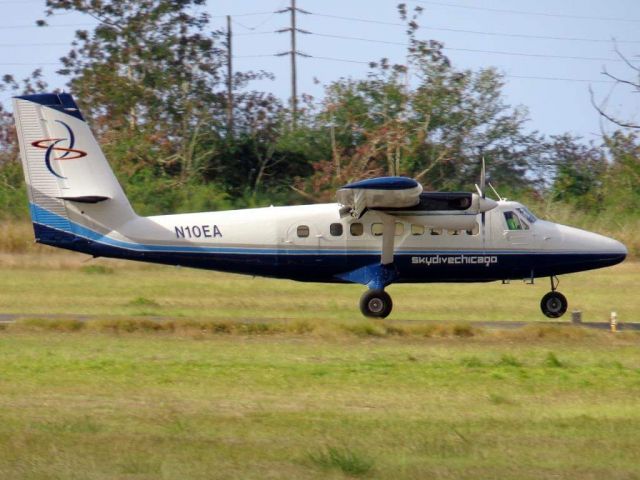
[{"x1": 13, "y1": 93, "x2": 136, "y2": 250}]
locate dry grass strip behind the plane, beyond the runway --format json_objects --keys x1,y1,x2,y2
[{"x1": 0, "y1": 253, "x2": 640, "y2": 320}]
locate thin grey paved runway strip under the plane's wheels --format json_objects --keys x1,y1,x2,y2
[{"x1": 0, "y1": 313, "x2": 640, "y2": 331}]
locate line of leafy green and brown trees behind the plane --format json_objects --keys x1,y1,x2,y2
[{"x1": 0, "y1": 0, "x2": 640, "y2": 229}]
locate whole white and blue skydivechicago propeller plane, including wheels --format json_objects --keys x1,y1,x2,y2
[{"x1": 14, "y1": 93, "x2": 627, "y2": 318}]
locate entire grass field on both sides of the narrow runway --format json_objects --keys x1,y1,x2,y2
[{"x1": 0, "y1": 251, "x2": 640, "y2": 480}]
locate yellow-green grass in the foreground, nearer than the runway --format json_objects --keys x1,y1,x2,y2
[{"x1": 0, "y1": 327, "x2": 640, "y2": 480}]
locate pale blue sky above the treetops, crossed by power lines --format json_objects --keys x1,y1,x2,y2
[{"x1": 0, "y1": 0, "x2": 640, "y2": 142}]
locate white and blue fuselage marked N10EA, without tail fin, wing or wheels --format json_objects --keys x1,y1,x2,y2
[{"x1": 35, "y1": 201, "x2": 627, "y2": 283}]
